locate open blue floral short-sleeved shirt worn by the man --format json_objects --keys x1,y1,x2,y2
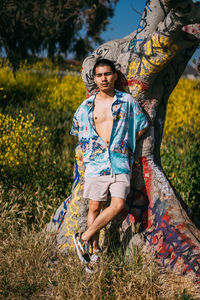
[{"x1": 71, "y1": 90, "x2": 148, "y2": 178}]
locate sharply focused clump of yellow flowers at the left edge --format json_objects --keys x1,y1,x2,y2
[{"x1": 0, "y1": 111, "x2": 47, "y2": 172}]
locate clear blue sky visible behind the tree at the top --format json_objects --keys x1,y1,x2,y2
[{"x1": 101, "y1": 0, "x2": 200, "y2": 63}]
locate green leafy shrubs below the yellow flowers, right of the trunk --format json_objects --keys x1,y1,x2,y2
[{"x1": 161, "y1": 136, "x2": 200, "y2": 218}]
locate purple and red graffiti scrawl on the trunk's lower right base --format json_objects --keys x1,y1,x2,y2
[{"x1": 147, "y1": 199, "x2": 200, "y2": 276}]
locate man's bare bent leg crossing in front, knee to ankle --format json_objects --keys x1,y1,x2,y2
[{"x1": 82, "y1": 197, "x2": 125, "y2": 241}]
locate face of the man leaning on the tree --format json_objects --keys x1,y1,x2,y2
[{"x1": 94, "y1": 66, "x2": 117, "y2": 92}]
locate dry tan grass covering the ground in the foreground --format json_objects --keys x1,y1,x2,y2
[{"x1": 0, "y1": 191, "x2": 200, "y2": 300}]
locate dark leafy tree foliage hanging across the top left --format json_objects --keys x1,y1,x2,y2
[{"x1": 0, "y1": 0, "x2": 118, "y2": 70}]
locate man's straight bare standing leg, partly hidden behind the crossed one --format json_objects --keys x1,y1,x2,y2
[{"x1": 87, "y1": 200, "x2": 102, "y2": 252}]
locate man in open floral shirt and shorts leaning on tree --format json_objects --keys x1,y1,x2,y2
[{"x1": 71, "y1": 59, "x2": 148, "y2": 263}]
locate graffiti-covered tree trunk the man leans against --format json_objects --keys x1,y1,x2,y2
[{"x1": 48, "y1": 0, "x2": 200, "y2": 278}]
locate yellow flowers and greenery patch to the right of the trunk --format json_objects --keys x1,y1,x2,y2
[{"x1": 161, "y1": 79, "x2": 200, "y2": 218}]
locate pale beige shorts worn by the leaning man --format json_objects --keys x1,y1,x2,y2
[{"x1": 83, "y1": 174, "x2": 130, "y2": 201}]
